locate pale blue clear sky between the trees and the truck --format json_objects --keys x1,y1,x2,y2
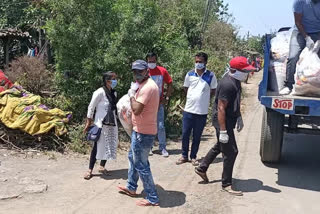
[{"x1": 224, "y1": 0, "x2": 294, "y2": 36}]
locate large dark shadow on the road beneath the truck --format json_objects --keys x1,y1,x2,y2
[{"x1": 267, "y1": 134, "x2": 320, "y2": 192}]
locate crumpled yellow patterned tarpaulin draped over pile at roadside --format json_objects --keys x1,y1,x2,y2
[{"x1": 0, "y1": 88, "x2": 71, "y2": 136}]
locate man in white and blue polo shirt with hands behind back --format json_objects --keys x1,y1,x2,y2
[{"x1": 176, "y1": 52, "x2": 217, "y2": 166}]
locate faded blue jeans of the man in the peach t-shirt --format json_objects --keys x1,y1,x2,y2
[{"x1": 127, "y1": 131, "x2": 159, "y2": 204}]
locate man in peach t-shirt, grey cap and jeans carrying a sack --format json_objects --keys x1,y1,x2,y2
[{"x1": 118, "y1": 60, "x2": 159, "y2": 206}]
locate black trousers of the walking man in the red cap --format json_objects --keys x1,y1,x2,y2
[{"x1": 200, "y1": 127, "x2": 238, "y2": 187}]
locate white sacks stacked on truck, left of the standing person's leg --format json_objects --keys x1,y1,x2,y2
[{"x1": 269, "y1": 30, "x2": 292, "y2": 92}]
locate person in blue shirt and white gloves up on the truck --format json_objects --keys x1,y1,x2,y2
[{"x1": 280, "y1": 0, "x2": 320, "y2": 95}]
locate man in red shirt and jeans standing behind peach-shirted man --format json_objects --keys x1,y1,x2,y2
[{"x1": 146, "y1": 52, "x2": 172, "y2": 157}]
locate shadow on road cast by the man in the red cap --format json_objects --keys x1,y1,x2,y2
[{"x1": 233, "y1": 179, "x2": 281, "y2": 193}]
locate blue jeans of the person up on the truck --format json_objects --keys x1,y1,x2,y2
[{"x1": 285, "y1": 30, "x2": 320, "y2": 90}]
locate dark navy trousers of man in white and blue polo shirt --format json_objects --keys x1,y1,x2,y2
[{"x1": 182, "y1": 112, "x2": 207, "y2": 159}]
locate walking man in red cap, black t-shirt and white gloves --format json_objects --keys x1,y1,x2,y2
[{"x1": 195, "y1": 57, "x2": 256, "y2": 196}]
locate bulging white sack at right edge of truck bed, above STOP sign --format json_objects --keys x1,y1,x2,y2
[{"x1": 292, "y1": 40, "x2": 320, "y2": 97}]
